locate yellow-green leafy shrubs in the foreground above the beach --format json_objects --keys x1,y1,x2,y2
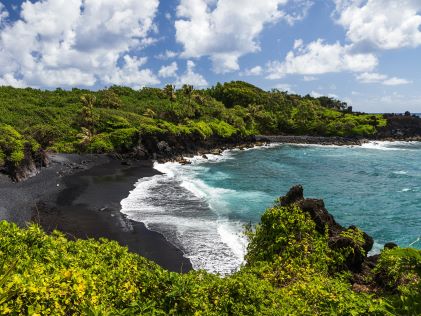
[{"x1": 0, "y1": 201, "x2": 421, "y2": 315}]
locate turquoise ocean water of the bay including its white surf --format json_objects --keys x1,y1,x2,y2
[{"x1": 121, "y1": 142, "x2": 421, "y2": 274}]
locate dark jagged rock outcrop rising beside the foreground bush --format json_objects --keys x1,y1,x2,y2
[{"x1": 280, "y1": 185, "x2": 374, "y2": 272}]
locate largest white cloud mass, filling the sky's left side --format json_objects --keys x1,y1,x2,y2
[{"x1": 0, "y1": 0, "x2": 159, "y2": 87}]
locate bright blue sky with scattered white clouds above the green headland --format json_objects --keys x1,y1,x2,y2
[{"x1": 0, "y1": 0, "x2": 421, "y2": 112}]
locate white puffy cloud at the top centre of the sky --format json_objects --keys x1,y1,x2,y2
[{"x1": 175, "y1": 0, "x2": 309, "y2": 73}]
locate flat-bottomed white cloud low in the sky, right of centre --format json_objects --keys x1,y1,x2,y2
[{"x1": 267, "y1": 39, "x2": 378, "y2": 79}]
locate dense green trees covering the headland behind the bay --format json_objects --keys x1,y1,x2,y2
[{"x1": 0, "y1": 81, "x2": 386, "y2": 169}]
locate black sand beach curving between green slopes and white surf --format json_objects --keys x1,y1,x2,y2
[{"x1": 0, "y1": 155, "x2": 192, "y2": 272}]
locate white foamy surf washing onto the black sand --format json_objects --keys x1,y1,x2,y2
[{"x1": 121, "y1": 153, "x2": 247, "y2": 275}]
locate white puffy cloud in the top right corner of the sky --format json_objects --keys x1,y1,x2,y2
[{"x1": 334, "y1": 0, "x2": 421, "y2": 49}]
